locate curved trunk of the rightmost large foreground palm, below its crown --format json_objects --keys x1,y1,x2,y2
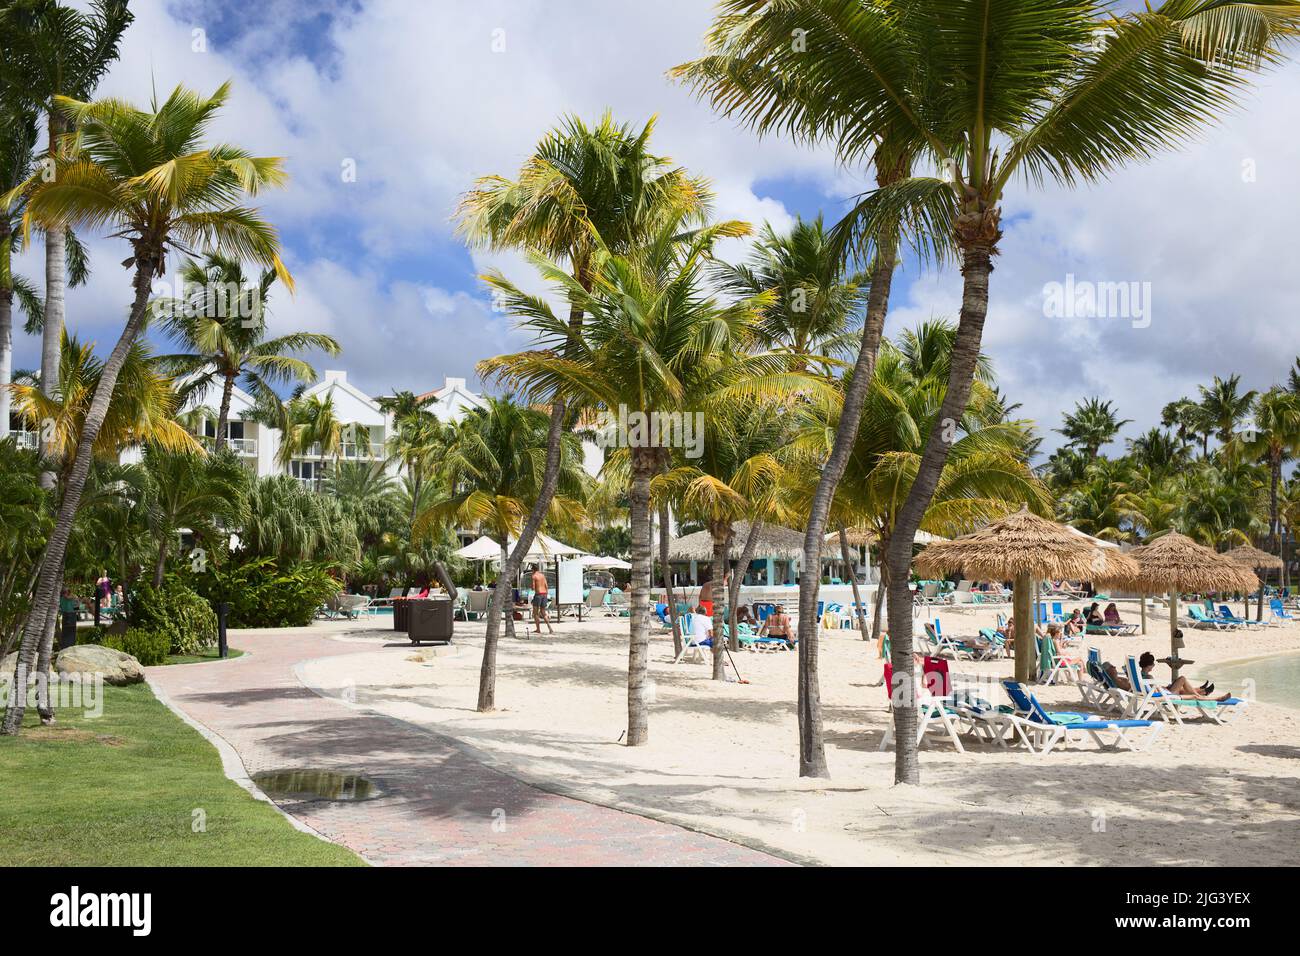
[{"x1": 885, "y1": 243, "x2": 993, "y2": 784}]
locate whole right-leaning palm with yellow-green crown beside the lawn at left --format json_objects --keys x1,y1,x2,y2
[{"x1": 0, "y1": 85, "x2": 293, "y2": 735}]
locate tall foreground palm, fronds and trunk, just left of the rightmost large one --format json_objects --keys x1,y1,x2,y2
[{"x1": 672, "y1": 0, "x2": 917, "y2": 777}]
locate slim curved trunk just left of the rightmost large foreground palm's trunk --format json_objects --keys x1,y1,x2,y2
[{"x1": 798, "y1": 243, "x2": 894, "y2": 777}]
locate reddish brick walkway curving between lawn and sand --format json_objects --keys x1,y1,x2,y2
[{"x1": 148, "y1": 632, "x2": 784, "y2": 866}]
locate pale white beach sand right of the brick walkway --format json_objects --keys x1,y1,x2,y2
[{"x1": 300, "y1": 609, "x2": 1300, "y2": 865}]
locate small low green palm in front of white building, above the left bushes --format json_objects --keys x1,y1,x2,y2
[{"x1": 143, "y1": 446, "x2": 248, "y2": 588}]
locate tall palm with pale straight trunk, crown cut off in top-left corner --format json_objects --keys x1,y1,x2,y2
[{"x1": 0, "y1": 0, "x2": 135, "y2": 486}]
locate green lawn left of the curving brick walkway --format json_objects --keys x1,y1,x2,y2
[{"x1": 0, "y1": 684, "x2": 364, "y2": 866}]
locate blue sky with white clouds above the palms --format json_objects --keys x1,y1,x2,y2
[{"x1": 16, "y1": 0, "x2": 1300, "y2": 463}]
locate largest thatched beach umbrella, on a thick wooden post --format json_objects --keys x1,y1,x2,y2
[{"x1": 915, "y1": 507, "x2": 1099, "y2": 682}]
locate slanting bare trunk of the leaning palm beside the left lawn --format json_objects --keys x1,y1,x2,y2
[{"x1": 0, "y1": 257, "x2": 160, "y2": 735}]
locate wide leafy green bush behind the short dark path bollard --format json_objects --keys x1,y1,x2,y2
[{"x1": 190, "y1": 558, "x2": 339, "y2": 627}]
